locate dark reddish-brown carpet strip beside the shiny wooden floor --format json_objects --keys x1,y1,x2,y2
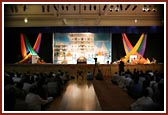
[{"x1": 93, "y1": 80, "x2": 135, "y2": 111}]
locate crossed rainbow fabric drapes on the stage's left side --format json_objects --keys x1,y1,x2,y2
[{"x1": 17, "y1": 33, "x2": 42, "y2": 64}]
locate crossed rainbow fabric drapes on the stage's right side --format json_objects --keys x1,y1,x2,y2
[{"x1": 122, "y1": 33, "x2": 150, "y2": 64}]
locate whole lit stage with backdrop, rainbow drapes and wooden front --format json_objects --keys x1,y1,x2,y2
[{"x1": 4, "y1": 33, "x2": 164, "y2": 78}]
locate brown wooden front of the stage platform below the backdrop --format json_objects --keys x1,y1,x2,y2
[{"x1": 4, "y1": 64, "x2": 164, "y2": 79}]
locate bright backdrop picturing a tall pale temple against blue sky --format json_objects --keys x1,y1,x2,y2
[{"x1": 53, "y1": 33, "x2": 112, "y2": 64}]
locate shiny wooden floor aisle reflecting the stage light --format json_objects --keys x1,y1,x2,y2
[{"x1": 46, "y1": 80, "x2": 101, "y2": 111}]
